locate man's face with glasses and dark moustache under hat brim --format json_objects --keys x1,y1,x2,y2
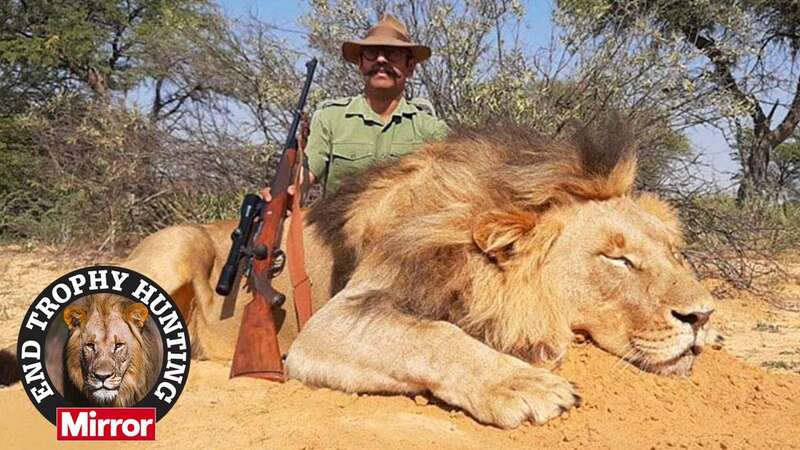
[{"x1": 359, "y1": 46, "x2": 416, "y2": 97}]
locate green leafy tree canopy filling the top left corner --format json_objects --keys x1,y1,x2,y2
[{"x1": 0, "y1": 0, "x2": 216, "y2": 109}]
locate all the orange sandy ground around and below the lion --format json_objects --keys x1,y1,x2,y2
[{"x1": 0, "y1": 247, "x2": 800, "y2": 449}]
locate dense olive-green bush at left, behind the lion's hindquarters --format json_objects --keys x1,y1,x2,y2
[{"x1": 0, "y1": 98, "x2": 250, "y2": 249}]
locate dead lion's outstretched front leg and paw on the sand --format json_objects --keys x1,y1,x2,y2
[{"x1": 286, "y1": 288, "x2": 579, "y2": 428}]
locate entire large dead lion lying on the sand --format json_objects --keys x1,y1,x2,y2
[{"x1": 111, "y1": 120, "x2": 713, "y2": 427}]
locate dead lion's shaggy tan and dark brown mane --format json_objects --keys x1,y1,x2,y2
[{"x1": 309, "y1": 118, "x2": 644, "y2": 361}]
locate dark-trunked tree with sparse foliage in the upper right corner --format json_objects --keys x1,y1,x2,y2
[{"x1": 558, "y1": 0, "x2": 800, "y2": 200}]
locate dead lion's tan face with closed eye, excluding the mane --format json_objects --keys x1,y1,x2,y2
[{"x1": 533, "y1": 195, "x2": 713, "y2": 375}]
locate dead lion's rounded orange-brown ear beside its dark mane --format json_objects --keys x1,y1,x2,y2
[{"x1": 472, "y1": 211, "x2": 536, "y2": 264}]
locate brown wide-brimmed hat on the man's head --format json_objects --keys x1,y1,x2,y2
[{"x1": 342, "y1": 14, "x2": 431, "y2": 64}]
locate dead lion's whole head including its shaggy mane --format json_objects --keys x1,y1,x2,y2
[{"x1": 310, "y1": 116, "x2": 713, "y2": 374}]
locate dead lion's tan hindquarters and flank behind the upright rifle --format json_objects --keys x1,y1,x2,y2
[{"x1": 118, "y1": 220, "x2": 333, "y2": 361}]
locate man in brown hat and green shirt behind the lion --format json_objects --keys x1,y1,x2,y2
[{"x1": 264, "y1": 14, "x2": 449, "y2": 200}]
